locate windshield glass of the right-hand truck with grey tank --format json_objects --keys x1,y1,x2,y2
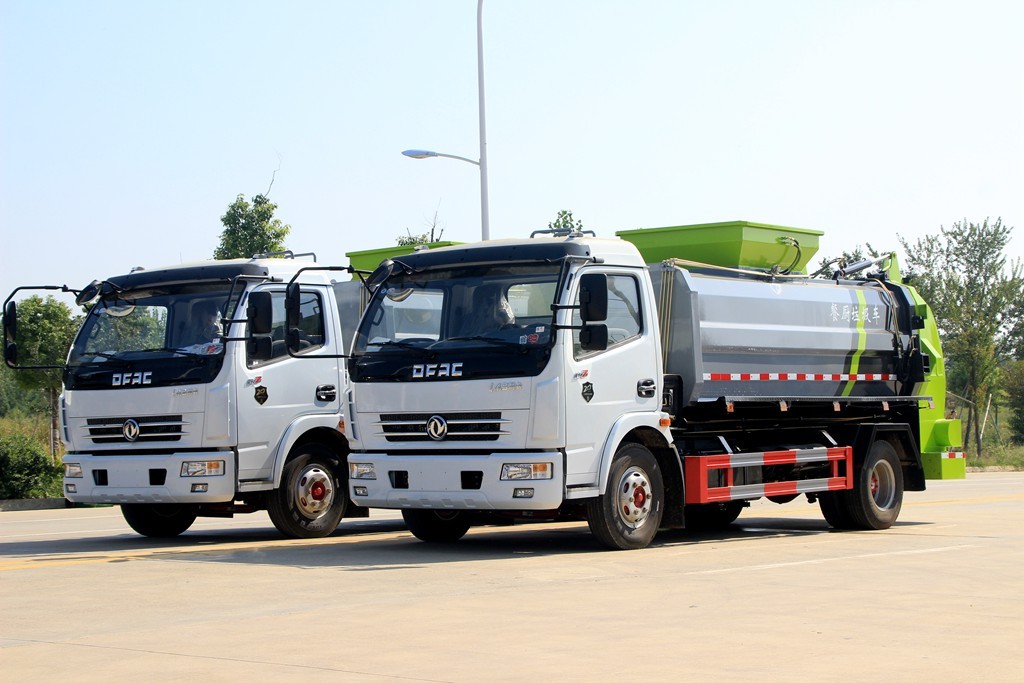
[{"x1": 354, "y1": 263, "x2": 559, "y2": 353}]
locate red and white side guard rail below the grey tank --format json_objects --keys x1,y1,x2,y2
[{"x1": 683, "y1": 445, "x2": 853, "y2": 503}]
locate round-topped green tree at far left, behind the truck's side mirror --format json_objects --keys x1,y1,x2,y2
[{"x1": 6, "y1": 296, "x2": 80, "y2": 456}]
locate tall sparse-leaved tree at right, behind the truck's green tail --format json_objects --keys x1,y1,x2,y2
[{"x1": 900, "y1": 218, "x2": 1024, "y2": 457}]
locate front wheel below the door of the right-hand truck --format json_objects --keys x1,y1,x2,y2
[{"x1": 587, "y1": 443, "x2": 665, "y2": 550}]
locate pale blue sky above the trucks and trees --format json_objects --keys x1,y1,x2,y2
[{"x1": 0, "y1": 0, "x2": 1024, "y2": 296}]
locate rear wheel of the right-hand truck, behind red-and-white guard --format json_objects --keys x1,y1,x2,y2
[{"x1": 818, "y1": 440, "x2": 903, "y2": 529}]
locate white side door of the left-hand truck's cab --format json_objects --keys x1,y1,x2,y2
[{"x1": 238, "y1": 288, "x2": 344, "y2": 480}]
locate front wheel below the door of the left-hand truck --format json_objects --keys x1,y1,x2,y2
[{"x1": 266, "y1": 443, "x2": 348, "y2": 539}]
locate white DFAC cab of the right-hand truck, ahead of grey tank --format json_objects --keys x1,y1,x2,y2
[{"x1": 349, "y1": 237, "x2": 671, "y2": 540}]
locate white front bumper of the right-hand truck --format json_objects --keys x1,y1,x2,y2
[{"x1": 348, "y1": 451, "x2": 565, "y2": 510}]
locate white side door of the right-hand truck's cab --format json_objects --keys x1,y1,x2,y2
[{"x1": 564, "y1": 268, "x2": 662, "y2": 485}]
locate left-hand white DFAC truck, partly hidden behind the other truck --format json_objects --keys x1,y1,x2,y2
[{"x1": 3, "y1": 252, "x2": 367, "y2": 538}]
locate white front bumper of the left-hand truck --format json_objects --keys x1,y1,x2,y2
[{"x1": 62, "y1": 451, "x2": 236, "y2": 505}]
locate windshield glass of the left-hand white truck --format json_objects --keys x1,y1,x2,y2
[{"x1": 69, "y1": 283, "x2": 230, "y2": 366}]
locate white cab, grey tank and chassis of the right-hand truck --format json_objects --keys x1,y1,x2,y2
[{"x1": 347, "y1": 227, "x2": 958, "y2": 549}]
